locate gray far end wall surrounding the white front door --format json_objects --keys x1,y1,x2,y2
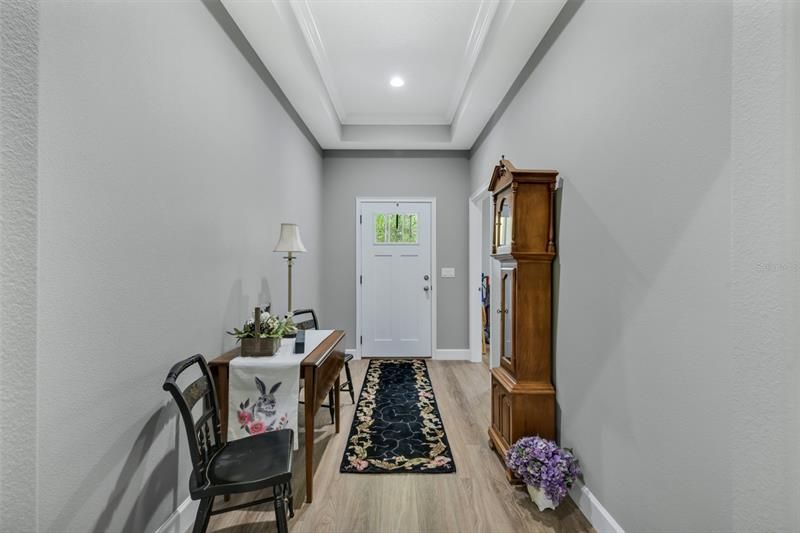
[{"x1": 321, "y1": 153, "x2": 470, "y2": 349}]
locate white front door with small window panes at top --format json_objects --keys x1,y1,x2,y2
[{"x1": 357, "y1": 201, "x2": 433, "y2": 357}]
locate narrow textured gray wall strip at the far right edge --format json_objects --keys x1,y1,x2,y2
[{"x1": 727, "y1": 2, "x2": 800, "y2": 531}]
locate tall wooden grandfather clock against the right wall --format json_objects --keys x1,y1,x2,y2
[{"x1": 489, "y1": 159, "x2": 558, "y2": 480}]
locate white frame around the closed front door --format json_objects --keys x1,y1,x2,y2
[{"x1": 355, "y1": 196, "x2": 439, "y2": 359}]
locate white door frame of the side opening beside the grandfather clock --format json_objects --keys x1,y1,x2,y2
[{"x1": 467, "y1": 181, "x2": 496, "y2": 366}]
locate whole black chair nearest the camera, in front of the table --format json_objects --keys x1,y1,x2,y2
[{"x1": 164, "y1": 354, "x2": 294, "y2": 533}]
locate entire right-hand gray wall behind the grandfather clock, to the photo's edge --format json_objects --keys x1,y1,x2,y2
[{"x1": 471, "y1": 2, "x2": 800, "y2": 531}]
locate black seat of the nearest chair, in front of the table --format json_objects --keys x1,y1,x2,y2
[{"x1": 197, "y1": 429, "x2": 294, "y2": 493}]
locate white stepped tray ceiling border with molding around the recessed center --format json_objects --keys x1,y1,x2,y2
[{"x1": 218, "y1": 0, "x2": 567, "y2": 150}]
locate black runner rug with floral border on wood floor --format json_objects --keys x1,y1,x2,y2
[{"x1": 340, "y1": 359, "x2": 456, "y2": 474}]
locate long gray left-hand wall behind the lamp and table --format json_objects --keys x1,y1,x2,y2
[{"x1": 32, "y1": 2, "x2": 322, "y2": 532}]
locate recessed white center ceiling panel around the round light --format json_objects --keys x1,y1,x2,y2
[{"x1": 304, "y1": 1, "x2": 490, "y2": 124}]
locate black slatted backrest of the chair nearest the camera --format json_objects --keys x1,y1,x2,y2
[{"x1": 164, "y1": 354, "x2": 222, "y2": 487}]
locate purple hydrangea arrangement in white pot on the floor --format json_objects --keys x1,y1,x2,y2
[{"x1": 506, "y1": 436, "x2": 581, "y2": 505}]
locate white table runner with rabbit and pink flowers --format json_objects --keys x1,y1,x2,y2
[{"x1": 228, "y1": 330, "x2": 333, "y2": 450}]
